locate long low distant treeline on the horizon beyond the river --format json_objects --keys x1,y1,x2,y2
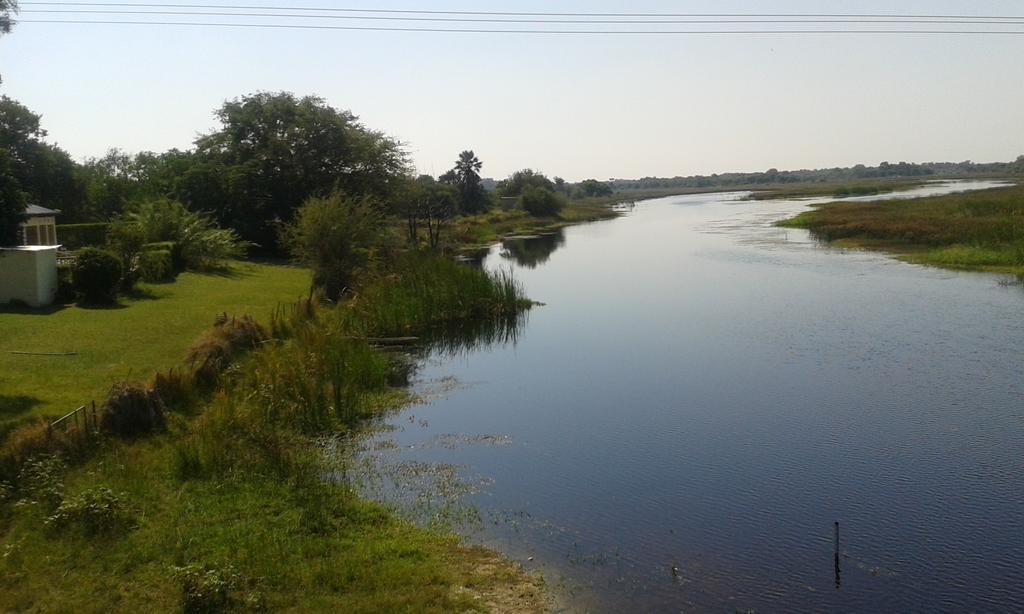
[{"x1": 608, "y1": 156, "x2": 1024, "y2": 191}]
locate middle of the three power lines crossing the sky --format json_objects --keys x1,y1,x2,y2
[{"x1": 22, "y1": 9, "x2": 1024, "y2": 26}]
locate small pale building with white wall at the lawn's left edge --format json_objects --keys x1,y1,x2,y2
[{"x1": 0, "y1": 205, "x2": 60, "y2": 307}]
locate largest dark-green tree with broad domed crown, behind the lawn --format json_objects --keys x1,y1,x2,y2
[{"x1": 191, "y1": 92, "x2": 408, "y2": 249}]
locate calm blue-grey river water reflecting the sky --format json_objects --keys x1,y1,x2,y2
[{"x1": 354, "y1": 184, "x2": 1024, "y2": 612}]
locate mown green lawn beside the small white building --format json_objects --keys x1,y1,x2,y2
[{"x1": 0, "y1": 263, "x2": 309, "y2": 438}]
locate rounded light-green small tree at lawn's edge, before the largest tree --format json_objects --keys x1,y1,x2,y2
[{"x1": 280, "y1": 191, "x2": 384, "y2": 300}]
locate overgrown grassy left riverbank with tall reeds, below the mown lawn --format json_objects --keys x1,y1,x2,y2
[{"x1": 0, "y1": 256, "x2": 547, "y2": 612}]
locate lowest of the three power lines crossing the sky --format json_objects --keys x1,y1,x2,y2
[{"x1": 18, "y1": 19, "x2": 1024, "y2": 36}]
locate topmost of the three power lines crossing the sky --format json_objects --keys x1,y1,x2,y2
[{"x1": 19, "y1": 1, "x2": 1024, "y2": 19}]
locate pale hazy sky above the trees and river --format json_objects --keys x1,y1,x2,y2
[{"x1": 0, "y1": 0, "x2": 1024, "y2": 179}]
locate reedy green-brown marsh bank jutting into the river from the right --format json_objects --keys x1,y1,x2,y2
[{"x1": 779, "y1": 180, "x2": 1024, "y2": 274}]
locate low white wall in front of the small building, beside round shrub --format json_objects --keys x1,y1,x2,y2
[{"x1": 0, "y1": 247, "x2": 57, "y2": 307}]
